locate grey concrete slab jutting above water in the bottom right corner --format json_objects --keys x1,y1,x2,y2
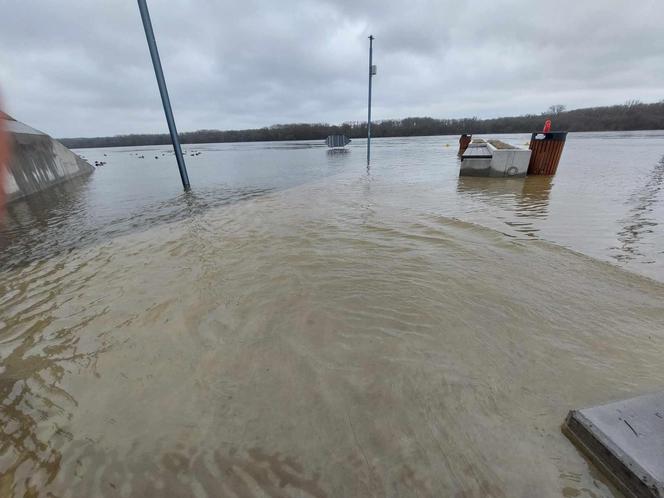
[{"x1": 563, "y1": 392, "x2": 664, "y2": 498}]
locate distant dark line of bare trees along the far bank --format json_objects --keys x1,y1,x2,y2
[{"x1": 60, "y1": 100, "x2": 664, "y2": 148}]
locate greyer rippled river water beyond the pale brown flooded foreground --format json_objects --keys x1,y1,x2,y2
[{"x1": 0, "y1": 131, "x2": 664, "y2": 281}]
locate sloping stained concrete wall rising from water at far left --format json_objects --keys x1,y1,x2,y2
[{"x1": 0, "y1": 115, "x2": 94, "y2": 202}]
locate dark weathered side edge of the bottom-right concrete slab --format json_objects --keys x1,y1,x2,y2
[{"x1": 561, "y1": 410, "x2": 664, "y2": 498}]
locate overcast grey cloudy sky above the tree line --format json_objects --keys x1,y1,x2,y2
[{"x1": 0, "y1": 0, "x2": 664, "y2": 137}]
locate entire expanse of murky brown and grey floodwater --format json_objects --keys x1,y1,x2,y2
[{"x1": 0, "y1": 132, "x2": 664, "y2": 498}]
